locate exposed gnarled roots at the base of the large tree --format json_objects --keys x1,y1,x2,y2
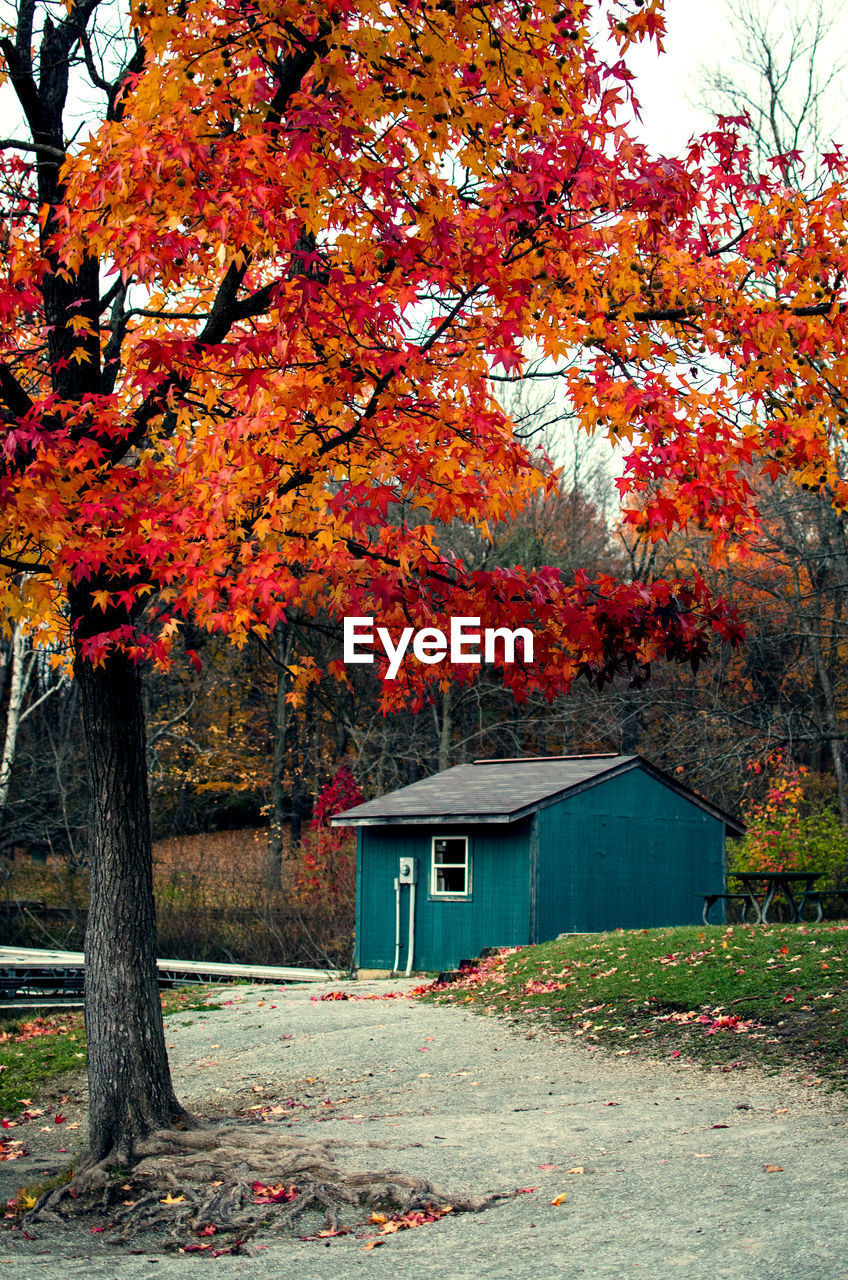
[{"x1": 26, "y1": 1124, "x2": 509, "y2": 1253}]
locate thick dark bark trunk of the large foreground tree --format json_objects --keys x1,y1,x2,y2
[{"x1": 76, "y1": 653, "x2": 190, "y2": 1164}]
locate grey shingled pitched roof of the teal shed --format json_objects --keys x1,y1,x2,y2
[{"x1": 332, "y1": 755, "x2": 743, "y2": 835}]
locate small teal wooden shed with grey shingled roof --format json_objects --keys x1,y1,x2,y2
[{"x1": 333, "y1": 755, "x2": 742, "y2": 973}]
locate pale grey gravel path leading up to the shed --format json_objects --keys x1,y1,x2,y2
[{"x1": 0, "y1": 982, "x2": 848, "y2": 1280}]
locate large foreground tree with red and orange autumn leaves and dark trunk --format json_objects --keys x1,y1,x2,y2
[{"x1": 0, "y1": 0, "x2": 847, "y2": 1182}]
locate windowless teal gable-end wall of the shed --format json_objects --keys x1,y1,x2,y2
[{"x1": 537, "y1": 769, "x2": 725, "y2": 941}]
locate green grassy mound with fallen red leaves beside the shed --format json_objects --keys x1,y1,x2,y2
[{"x1": 427, "y1": 922, "x2": 848, "y2": 1088}]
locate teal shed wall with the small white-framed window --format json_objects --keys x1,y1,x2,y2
[{"x1": 356, "y1": 819, "x2": 530, "y2": 970}]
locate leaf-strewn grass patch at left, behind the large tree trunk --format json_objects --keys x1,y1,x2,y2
[{"x1": 0, "y1": 986, "x2": 220, "y2": 1119}]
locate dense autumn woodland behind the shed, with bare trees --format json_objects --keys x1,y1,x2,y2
[{"x1": 0, "y1": 3, "x2": 848, "y2": 964}]
